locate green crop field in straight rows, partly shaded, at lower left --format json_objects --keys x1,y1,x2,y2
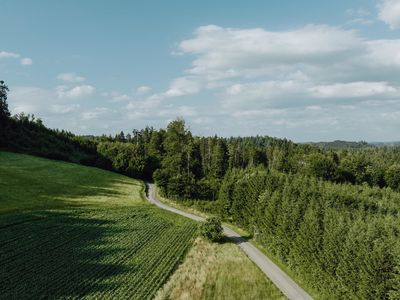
[{"x1": 0, "y1": 205, "x2": 196, "y2": 299}]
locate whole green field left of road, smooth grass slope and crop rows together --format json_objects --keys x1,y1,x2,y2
[{"x1": 0, "y1": 152, "x2": 196, "y2": 299}]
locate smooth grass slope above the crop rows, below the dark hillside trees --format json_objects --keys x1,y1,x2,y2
[{"x1": 0, "y1": 151, "x2": 143, "y2": 213}]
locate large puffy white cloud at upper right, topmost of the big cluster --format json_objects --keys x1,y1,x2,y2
[{"x1": 179, "y1": 25, "x2": 363, "y2": 80}]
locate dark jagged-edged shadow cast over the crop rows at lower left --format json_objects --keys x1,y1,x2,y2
[{"x1": 0, "y1": 209, "x2": 127, "y2": 299}]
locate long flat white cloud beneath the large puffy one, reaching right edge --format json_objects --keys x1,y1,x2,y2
[{"x1": 222, "y1": 80, "x2": 400, "y2": 110}]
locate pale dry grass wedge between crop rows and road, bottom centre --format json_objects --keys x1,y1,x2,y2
[{"x1": 156, "y1": 238, "x2": 285, "y2": 300}]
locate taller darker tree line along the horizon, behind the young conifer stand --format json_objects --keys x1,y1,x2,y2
[{"x1": 0, "y1": 82, "x2": 400, "y2": 193}]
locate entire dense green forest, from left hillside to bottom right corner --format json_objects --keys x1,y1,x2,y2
[{"x1": 0, "y1": 82, "x2": 400, "y2": 299}]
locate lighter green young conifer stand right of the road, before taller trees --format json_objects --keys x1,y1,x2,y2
[{"x1": 216, "y1": 169, "x2": 400, "y2": 299}]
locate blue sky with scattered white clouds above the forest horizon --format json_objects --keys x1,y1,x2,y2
[{"x1": 0, "y1": 0, "x2": 400, "y2": 141}]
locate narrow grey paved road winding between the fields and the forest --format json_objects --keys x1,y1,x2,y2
[{"x1": 147, "y1": 184, "x2": 312, "y2": 300}]
